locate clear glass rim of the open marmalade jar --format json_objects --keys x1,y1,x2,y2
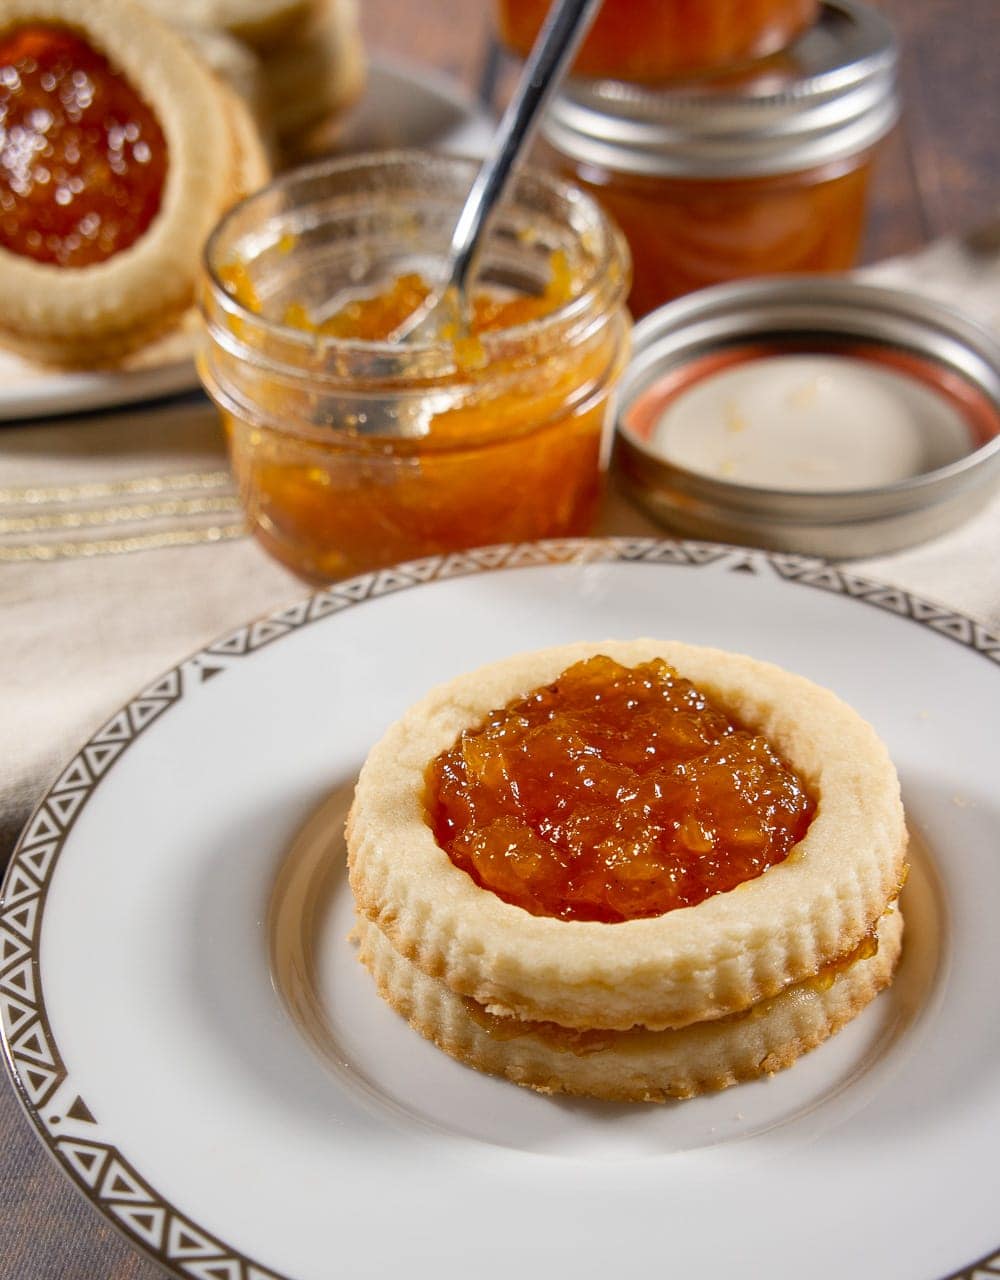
[{"x1": 202, "y1": 148, "x2": 630, "y2": 372}]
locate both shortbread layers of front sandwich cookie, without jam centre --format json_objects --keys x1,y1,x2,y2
[{"x1": 347, "y1": 640, "x2": 907, "y2": 1101}]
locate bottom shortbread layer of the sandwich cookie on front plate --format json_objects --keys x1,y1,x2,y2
[{"x1": 356, "y1": 909, "x2": 903, "y2": 1102}]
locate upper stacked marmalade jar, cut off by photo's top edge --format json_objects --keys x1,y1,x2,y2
[{"x1": 497, "y1": 0, "x2": 818, "y2": 82}]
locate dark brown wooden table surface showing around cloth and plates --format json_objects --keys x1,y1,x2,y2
[{"x1": 0, "y1": 0, "x2": 1000, "y2": 1280}]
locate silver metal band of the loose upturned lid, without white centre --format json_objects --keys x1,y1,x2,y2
[{"x1": 613, "y1": 276, "x2": 1000, "y2": 557}]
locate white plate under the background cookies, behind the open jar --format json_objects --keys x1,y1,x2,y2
[{"x1": 0, "y1": 59, "x2": 490, "y2": 422}]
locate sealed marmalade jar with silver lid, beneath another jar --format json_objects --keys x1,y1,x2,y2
[{"x1": 543, "y1": 0, "x2": 899, "y2": 316}]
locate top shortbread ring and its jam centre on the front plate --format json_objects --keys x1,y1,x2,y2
[{"x1": 347, "y1": 640, "x2": 907, "y2": 1030}]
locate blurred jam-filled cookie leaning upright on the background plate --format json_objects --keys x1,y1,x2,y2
[{"x1": 0, "y1": 0, "x2": 268, "y2": 367}]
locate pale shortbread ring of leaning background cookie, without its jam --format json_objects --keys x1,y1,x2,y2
[{"x1": 0, "y1": 0, "x2": 268, "y2": 367}]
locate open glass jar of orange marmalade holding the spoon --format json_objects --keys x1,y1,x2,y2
[{"x1": 201, "y1": 152, "x2": 630, "y2": 581}]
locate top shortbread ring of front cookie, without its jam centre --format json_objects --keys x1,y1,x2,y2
[{"x1": 347, "y1": 640, "x2": 907, "y2": 1030}]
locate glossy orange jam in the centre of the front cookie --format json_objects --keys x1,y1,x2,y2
[{"x1": 426, "y1": 655, "x2": 816, "y2": 923}]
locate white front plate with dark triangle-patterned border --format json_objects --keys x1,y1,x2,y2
[{"x1": 0, "y1": 539, "x2": 1000, "y2": 1280}]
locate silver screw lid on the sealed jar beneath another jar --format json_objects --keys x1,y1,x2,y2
[{"x1": 542, "y1": 0, "x2": 899, "y2": 178}]
